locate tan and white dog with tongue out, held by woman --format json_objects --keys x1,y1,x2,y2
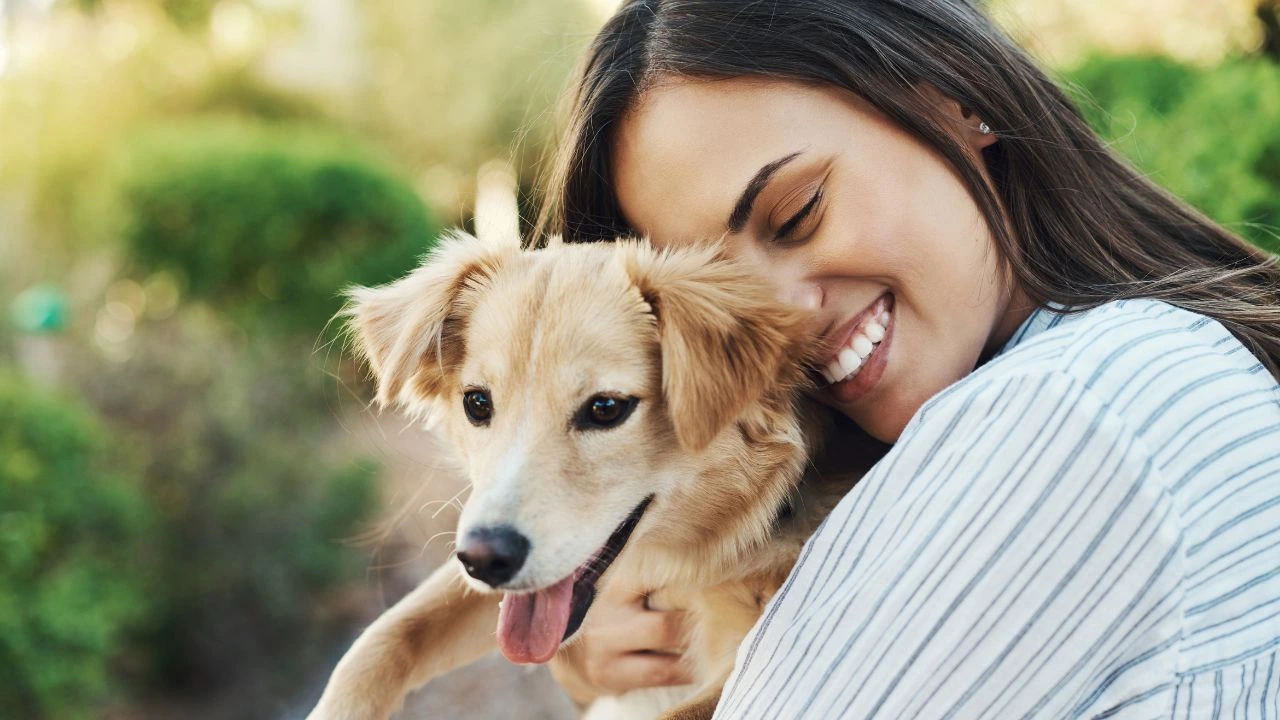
[{"x1": 310, "y1": 174, "x2": 865, "y2": 720}]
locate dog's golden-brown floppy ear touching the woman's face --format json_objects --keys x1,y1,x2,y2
[{"x1": 627, "y1": 243, "x2": 809, "y2": 451}]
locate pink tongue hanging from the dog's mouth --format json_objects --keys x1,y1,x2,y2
[{"x1": 498, "y1": 575, "x2": 573, "y2": 664}]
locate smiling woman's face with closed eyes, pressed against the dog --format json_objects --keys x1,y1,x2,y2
[{"x1": 613, "y1": 79, "x2": 1029, "y2": 442}]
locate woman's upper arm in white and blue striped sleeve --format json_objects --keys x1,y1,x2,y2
[{"x1": 717, "y1": 372, "x2": 1183, "y2": 719}]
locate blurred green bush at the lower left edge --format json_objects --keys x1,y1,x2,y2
[{"x1": 0, "y1": 374, "x2": 154, "y2": 719}]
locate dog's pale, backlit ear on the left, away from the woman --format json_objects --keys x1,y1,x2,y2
[{"x1": 343, "y1": 232, "x2": 520, "y2": 406}]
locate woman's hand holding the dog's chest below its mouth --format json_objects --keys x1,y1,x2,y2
[{"x1": 552, "y1": 583, "x2": 692, "y2": 705}]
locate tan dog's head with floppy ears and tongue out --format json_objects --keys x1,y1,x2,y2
[{"x1": 348, "y1": 184, "x2": 805, "y2": 662}]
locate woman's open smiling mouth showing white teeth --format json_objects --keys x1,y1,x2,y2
[{"x1": 819, "y1": 293, "x2": 893, "y2": 402}]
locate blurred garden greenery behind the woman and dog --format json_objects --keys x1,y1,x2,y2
[{"x1": 0, "y1": 0, "x2": 1280, "y2": 719}]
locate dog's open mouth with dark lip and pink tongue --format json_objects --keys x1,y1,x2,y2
[{"x1": 498, "y1": 495, "x2": 653, "y2": 664}]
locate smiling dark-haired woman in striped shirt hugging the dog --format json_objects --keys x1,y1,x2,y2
[{"x1": 541, "y1": 0, "x2": 1280, "y2": 719}]
